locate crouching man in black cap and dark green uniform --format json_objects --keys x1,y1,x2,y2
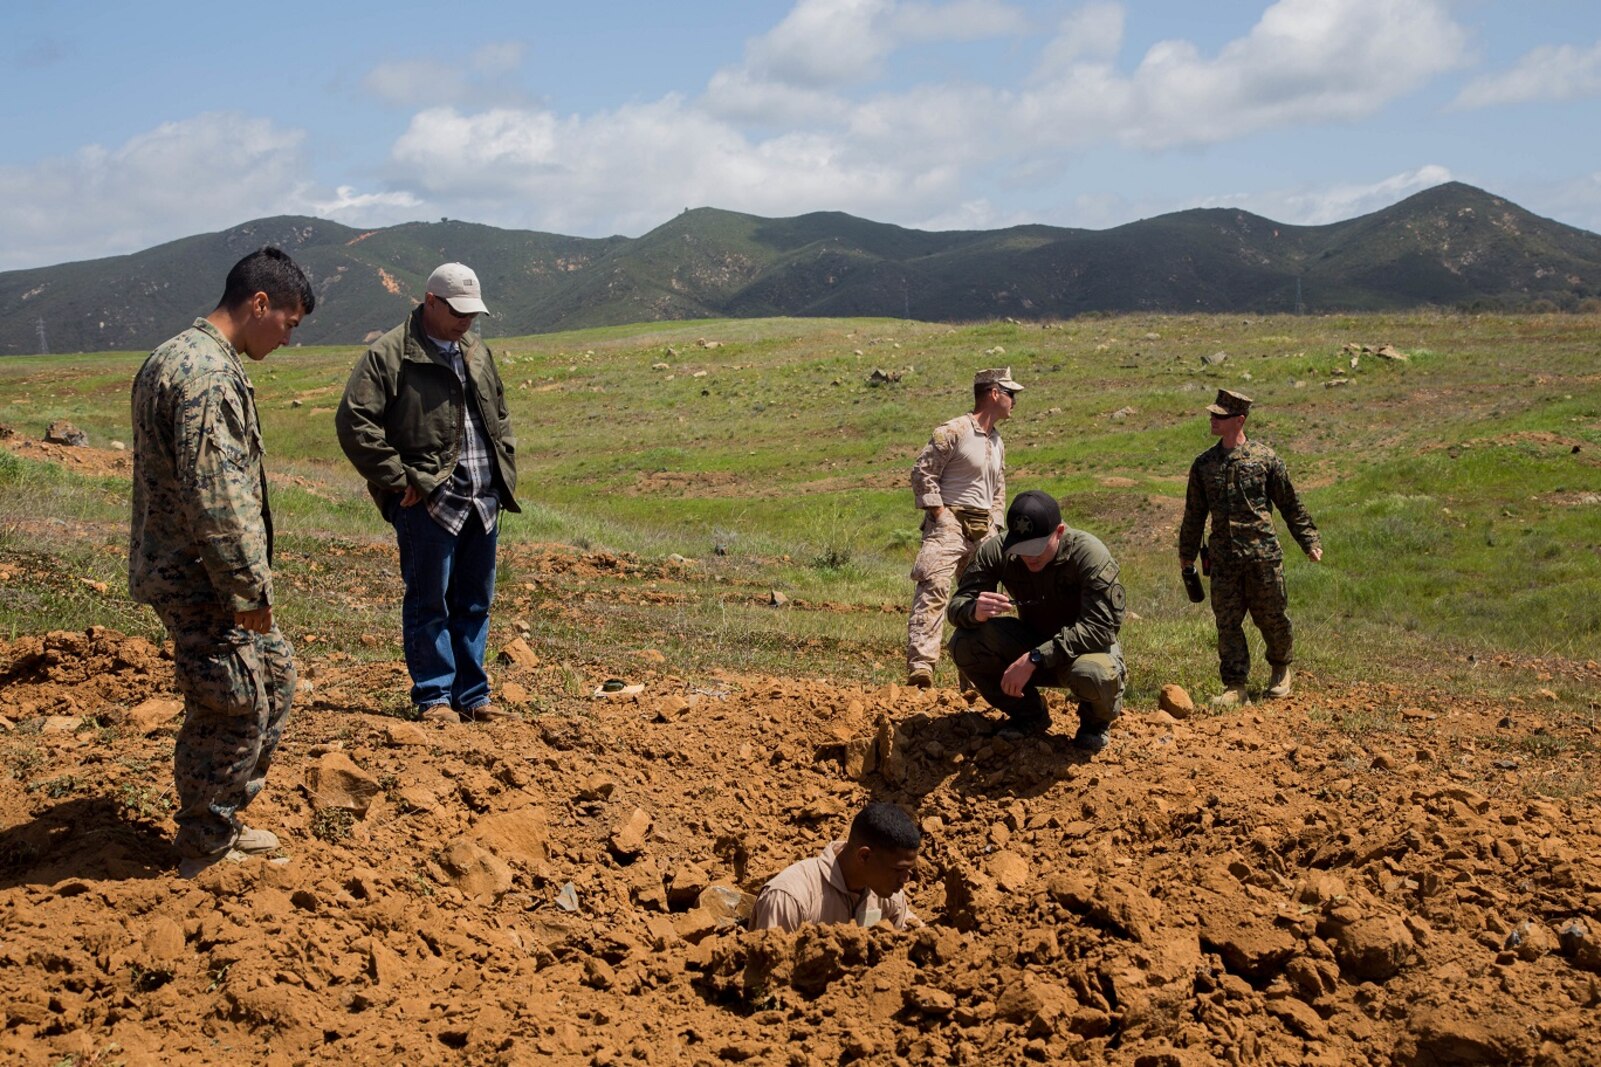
[{"x1": 945, "y1": 489, "x2": 1127, "y2": 753}]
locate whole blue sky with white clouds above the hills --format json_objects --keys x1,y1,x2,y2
[{"x1": 0, "y1": 0, "x2": 1601, "y2": 269}]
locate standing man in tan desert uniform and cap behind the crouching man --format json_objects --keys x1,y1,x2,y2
[{"x1": 906, "y1": 367, "x2": 1023, "y2": 687}]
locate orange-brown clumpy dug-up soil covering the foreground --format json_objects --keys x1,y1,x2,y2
[{"x1": 0, "y1": 628, "x2": 1601, "y2": 1067}]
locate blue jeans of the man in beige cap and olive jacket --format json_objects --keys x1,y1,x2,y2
[{"x1": 389, "y1": 498, "x2": 500, "y2": 711}]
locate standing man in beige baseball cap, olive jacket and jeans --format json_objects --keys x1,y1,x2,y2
[{"x1": 335, "y1": 263, "x2": 519, "y2": 723}]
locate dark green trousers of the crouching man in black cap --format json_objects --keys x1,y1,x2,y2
[{"x1": 951, "y1": 615, "x2": 1129, "y2": 726}]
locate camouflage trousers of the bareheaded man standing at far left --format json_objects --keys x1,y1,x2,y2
[{"x1": 157, "y1": 604, "x2": 295, "y2": 856}]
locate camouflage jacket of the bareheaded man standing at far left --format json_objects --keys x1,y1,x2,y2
[{"x1": 128, "y1": 319, "x2": 272, "y2": 612}]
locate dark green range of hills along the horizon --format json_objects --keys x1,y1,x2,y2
[{"x1": 0, "y1": 183, "x2": 1601, "y2": 354}]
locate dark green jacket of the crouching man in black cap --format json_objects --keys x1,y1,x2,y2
[{"x1": 945, "y1": 525, "x2": 1126, "y2": 668}]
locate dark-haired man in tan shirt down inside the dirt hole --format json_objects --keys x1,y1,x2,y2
[{"x1": 751, "y1": 803, "x2": 922, "y2": 931}]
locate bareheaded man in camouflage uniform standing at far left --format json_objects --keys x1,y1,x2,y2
[{"x1": 128, "y1": 248, "x2": 317, "y2": 876}]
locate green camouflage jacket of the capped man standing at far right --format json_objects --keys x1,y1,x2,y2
[{"x1": 1178, "y1": 441, "x2": 1319, "y2": 561}]
